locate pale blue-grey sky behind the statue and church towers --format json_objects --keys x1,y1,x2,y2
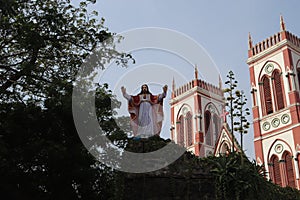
[{"x1": 75, "y1": 0, "x2": 300, "y2": 158}]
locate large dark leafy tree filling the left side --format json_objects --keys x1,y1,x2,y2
[{"x1": 0, "y1": 0, "x2": 130, "y2": 199}]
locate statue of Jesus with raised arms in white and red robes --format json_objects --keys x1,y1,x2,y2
[{"x1": 121, "y1": 84, "x2": 168, "y2": 138}]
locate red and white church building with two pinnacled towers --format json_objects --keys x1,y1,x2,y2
[{"x1": 170, "y1": 16, "x2": 300, "y2": 189}]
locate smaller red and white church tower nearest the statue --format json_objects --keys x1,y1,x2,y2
[{"x1": 170, "y1": 67, "x2": 224, "y2": 157}]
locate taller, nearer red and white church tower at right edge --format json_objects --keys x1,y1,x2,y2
[{"x1": 247, "y1": 16, "x2": 300, "y2": 189}]
